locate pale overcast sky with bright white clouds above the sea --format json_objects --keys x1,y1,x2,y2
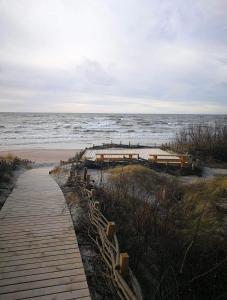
[{"x1": 0, "y1": 0, "x2": 227, "y2": 114}]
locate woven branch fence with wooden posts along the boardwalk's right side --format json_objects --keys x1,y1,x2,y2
[{"x1": 68, "y1": 166, "x2": 143, "y2": 300}]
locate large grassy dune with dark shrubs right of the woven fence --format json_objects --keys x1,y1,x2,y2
[{"x1": 103, "y1": 165, "x2": 227, "y2": 300}]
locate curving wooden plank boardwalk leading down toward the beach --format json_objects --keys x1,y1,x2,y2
[{"x1": 0, "y1": 169, "x2": 90, "y2": 300}]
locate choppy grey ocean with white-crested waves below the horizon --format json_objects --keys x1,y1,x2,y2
[{"x1": 0, "y1": 113, "x2": 227, "y2": 150}]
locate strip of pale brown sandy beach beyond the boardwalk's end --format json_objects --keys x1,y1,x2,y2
[{"x1": 0, "y1": 149, "x2": 80, "y2": 163}]
